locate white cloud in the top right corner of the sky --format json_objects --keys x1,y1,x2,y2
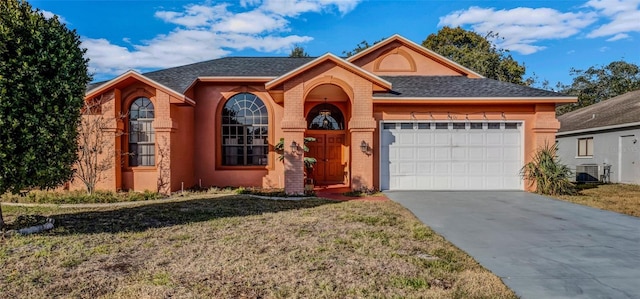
[{"x1": 585, "y1": 0, "x2": 640, "y2": 41}]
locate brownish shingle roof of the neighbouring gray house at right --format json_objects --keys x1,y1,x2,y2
[{"x1": 558, "y1": 90, "x2": 640, "y2": 132}]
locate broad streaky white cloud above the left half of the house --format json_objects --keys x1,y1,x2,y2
[{"x1": 82, "y1": 0, "x2": 361, "y2": 78}]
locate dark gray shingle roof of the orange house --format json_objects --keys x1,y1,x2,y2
[{"x1": 89, "y1": 57, "x2": 562, "y2": 98}]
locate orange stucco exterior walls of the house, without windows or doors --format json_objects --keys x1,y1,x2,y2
[{"x1": 71, "y1": 35, "x2": 559, "y2": 193}]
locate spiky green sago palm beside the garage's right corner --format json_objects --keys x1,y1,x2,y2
[{"x1": 520, "y1": 143, "x2": 576, "y2": 195}]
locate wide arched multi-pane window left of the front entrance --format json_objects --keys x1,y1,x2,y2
[{"x1": 222, "y1": 93, "x2": 269, "y2": 166}]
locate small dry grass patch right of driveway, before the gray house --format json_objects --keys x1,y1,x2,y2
[{"x1": 558, "y1": 184, "x2": 640, "y2": 217}]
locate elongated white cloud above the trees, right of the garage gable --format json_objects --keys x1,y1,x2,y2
[{"x1": 438, "y1": 7, "x2": 597, "y2": 55}]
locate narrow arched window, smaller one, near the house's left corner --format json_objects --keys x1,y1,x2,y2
[{"x1": 129, "y1": 98, "x2": 156, "y2": 166}]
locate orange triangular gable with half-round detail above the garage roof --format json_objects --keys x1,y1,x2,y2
[{"x1": 347, "y1": 34, "x2": 484, "y2": 78}]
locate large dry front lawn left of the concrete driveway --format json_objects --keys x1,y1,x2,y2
[{"x1": 0, "y1": 195, "x2": 515, "y2": 298}]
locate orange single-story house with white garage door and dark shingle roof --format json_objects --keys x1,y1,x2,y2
[{"x1": 79, "y1": 35, "x2": 576, "y2": 194}]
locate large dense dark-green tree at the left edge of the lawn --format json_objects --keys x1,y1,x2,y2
[{"x1": 0, "y1": 0, "x2": 91, "y2": 225}]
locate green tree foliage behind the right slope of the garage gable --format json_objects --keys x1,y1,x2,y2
[{"x1": 422, "y1": 27, "x2": 527, "y2": 85}]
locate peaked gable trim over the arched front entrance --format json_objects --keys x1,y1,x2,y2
[{"x1": 265, "y1": 53, "x2": 391, "y2": 90}]
